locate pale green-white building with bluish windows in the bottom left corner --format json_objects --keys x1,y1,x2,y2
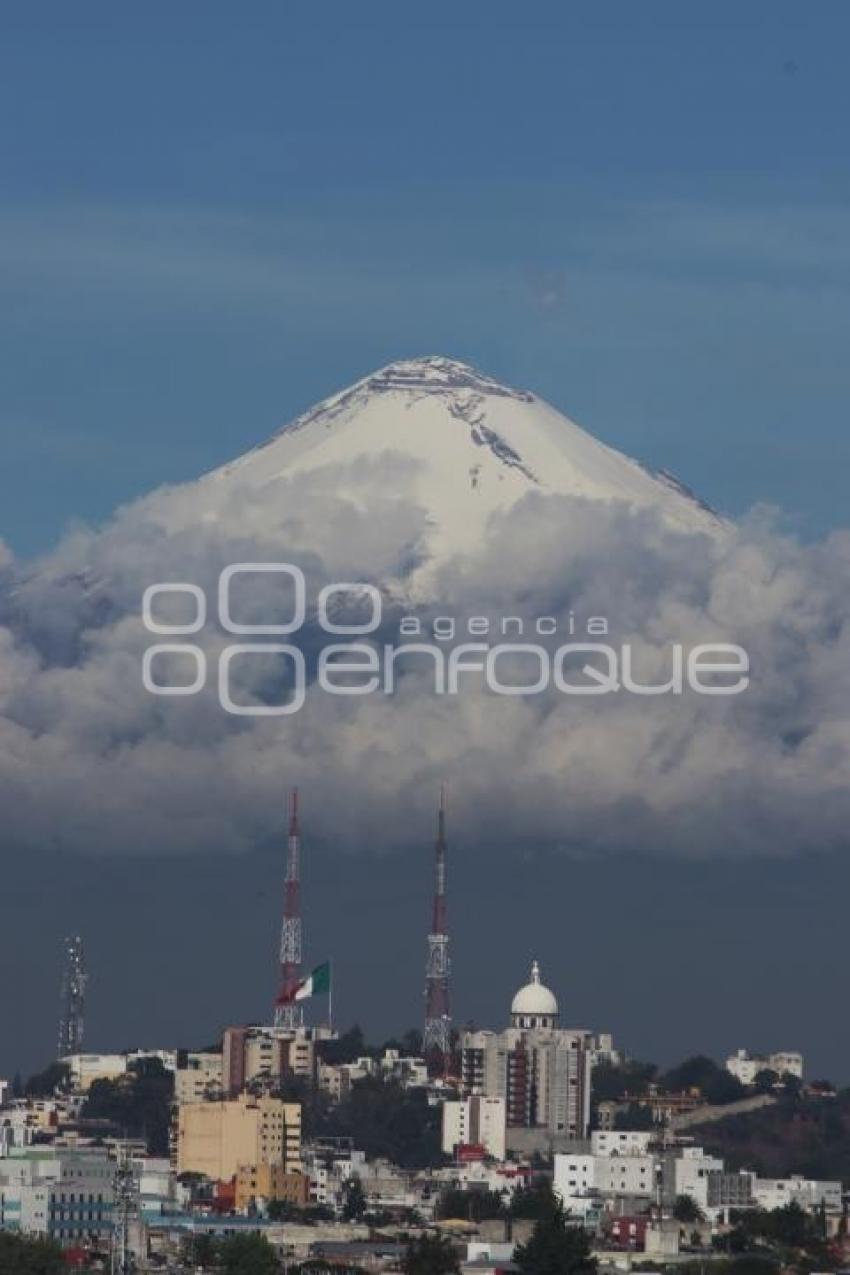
[{"x1": 0, "y1": 1148, "x2": 115, "y2": 1248}]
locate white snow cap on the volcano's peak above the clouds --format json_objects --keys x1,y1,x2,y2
[{"x1": 201, "y1": 357, "x2": 724, "y2": 560}]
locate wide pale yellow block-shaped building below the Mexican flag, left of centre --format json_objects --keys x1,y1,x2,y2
[{"x1": 177, "y1": 1094, "x2": 301, "y2": 1182}]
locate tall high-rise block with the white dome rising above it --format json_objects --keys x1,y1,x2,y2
[{"x1": 461, "y1": 961, "x2": 595, "y2": 1151}]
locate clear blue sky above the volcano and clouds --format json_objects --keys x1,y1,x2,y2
[{"x1": 0, "y1": 0, "x2": 850, "y2": 555}]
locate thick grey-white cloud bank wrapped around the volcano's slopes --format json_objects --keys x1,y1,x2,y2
[{"x1": 0, "y1": 456, "x2": 850, "y2": 857}]
